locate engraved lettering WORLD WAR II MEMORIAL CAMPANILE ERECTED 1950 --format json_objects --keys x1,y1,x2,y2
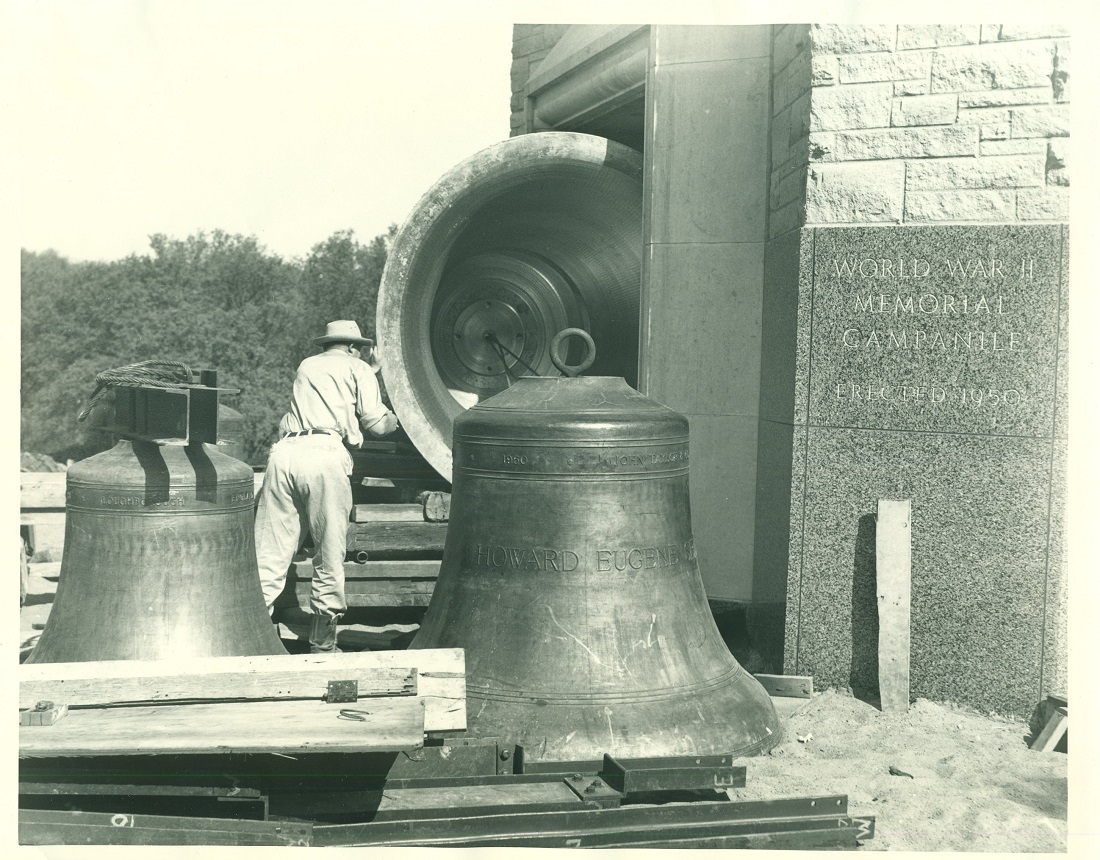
[{"x1": 828, "y1": 255, "x2": 1036, "y2": 409}]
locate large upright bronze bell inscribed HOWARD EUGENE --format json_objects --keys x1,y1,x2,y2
[{"x1": 411, "y1": 334, "x2": 781, "y2": 761}]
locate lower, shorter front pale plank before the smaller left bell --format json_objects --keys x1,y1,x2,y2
[{"x1": 19, "y1": 697, "x2": 425, "y2": 757}]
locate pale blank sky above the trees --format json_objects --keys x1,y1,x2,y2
[{"x1": 18, "y1": 0, "x2": 512, "y2": 260}]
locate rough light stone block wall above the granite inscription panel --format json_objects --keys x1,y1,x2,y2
[{"x1": 800, "y1": 24, "x2": 1069, "y2": 228}]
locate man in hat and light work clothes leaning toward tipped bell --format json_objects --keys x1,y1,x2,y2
[{"x1": 255, "y1": 320, "x2": 397, "y2": 653}]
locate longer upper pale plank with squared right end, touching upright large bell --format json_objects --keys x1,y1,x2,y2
[{"x1": 18, "y1": 648, "x2": 466, "y2": 731}]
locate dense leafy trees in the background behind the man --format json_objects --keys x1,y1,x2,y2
[{"x1": 20, "y1": 225, "x2": 396, "y2": 464}]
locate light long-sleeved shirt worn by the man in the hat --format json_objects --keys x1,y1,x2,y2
[{"x1": 279, "y1": 350, "x2": 389, "y2": 448}]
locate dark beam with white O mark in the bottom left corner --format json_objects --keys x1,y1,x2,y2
[{"x1": 19, "y1": 809, "x2": 312, "y2": 846}]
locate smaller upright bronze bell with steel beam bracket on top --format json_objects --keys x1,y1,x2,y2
[{"x1": 26, "y1": 440, "x2": 286, "y2": 663}]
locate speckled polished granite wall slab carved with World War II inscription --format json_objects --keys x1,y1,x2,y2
[{"x1": 758, "y1": 224, "x2": 1068, "y2": 713}]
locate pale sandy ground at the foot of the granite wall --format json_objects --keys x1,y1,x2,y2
[{"x1": 20, "y1": 564, "x2": 1068, "y2": 852}]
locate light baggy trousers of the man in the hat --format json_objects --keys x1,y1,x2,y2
[{"x1": 255, "y1": 434, "x2": 352, "y2": 617}]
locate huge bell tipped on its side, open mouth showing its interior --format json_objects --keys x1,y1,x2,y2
[{"x1": 377, "y1": 132, "x2": 644, "y2": 479}]
